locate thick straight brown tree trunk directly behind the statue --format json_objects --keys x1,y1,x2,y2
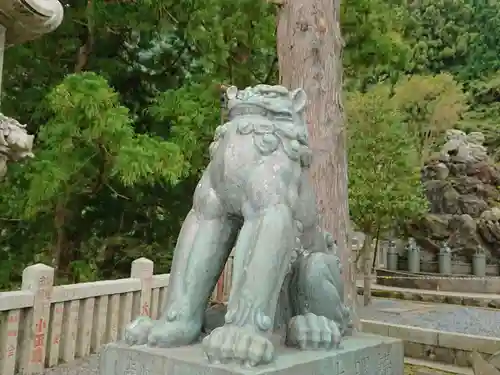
[{"x1": 277, "y1": 0, "x2": 359, "y2": 327}]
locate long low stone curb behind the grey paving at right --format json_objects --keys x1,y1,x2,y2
[{"x1": 356, "y1": 280, "x2": 500, "y2": 309}]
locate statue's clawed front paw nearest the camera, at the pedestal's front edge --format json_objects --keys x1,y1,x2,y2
[{"x1": 203, "y1": 325, "x2": 274, "y2": 367}]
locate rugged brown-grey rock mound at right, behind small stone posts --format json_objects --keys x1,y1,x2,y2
[{"x1": 410, "y1": 129, "x2": 500, "y2": 262}]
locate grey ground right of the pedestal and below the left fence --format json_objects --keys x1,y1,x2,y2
[{"x1": 44, "y1": 298, "x2": 500, "y2": 375}]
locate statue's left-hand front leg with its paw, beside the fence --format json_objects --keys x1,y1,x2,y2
[{"x1": 126, "y1": 172, "x2": 238, "y2": 347}]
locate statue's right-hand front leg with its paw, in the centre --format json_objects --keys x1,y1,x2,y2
[{"x1": 203, "y1": 203, "x2": 294, "y2": 366}]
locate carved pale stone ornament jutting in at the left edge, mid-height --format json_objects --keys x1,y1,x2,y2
[{"x1": 0, "y1": 114, "x2": 34, "y2": 178}]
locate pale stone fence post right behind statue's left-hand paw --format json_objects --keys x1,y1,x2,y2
[{"x1": 130, "y1": 258, "x2": 154, "y2": 319}]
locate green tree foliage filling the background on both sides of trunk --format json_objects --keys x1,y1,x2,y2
[{"x1": 0, "y1": 0, "x2": 500, "y2": 288}]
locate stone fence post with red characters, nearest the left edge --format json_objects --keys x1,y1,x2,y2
[{"x1": 19, "y1": 263, "x2": 54, "y2": 375}]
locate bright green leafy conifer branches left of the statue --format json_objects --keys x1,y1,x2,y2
[{"x1": 15, "y1": 73, "x2": 185, "y2": 217}]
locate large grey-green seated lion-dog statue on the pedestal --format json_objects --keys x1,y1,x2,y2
[{"x1": 125, "y1": 85, "x2": 351, "y2": 366}]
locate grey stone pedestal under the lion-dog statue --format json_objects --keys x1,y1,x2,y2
[{"x1": 99, "y1": 334, "x2": 404, "y2": 375}]
